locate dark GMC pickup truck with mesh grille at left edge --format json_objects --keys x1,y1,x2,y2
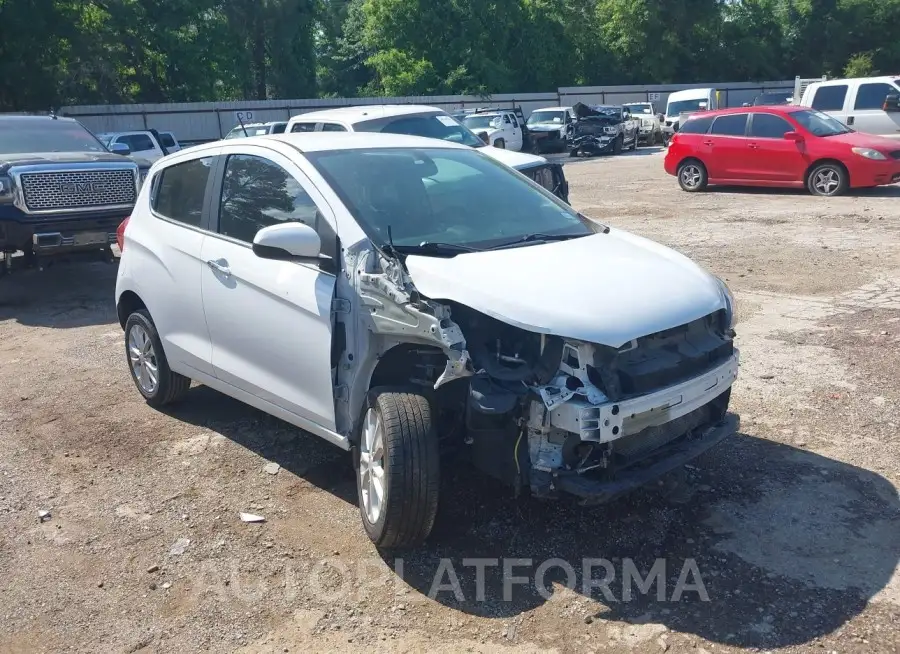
[{"x1": 0, "y1": 116, "x2": 146, "y2": 274}]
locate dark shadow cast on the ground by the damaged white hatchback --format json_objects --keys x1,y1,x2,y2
[{"x1": 158, "y1": 387, "x2": 900, "y2": 648}]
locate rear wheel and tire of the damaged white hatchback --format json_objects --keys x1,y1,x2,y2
[{"x1": 125, "y1": 309, "x2": 191, "y2": 408}]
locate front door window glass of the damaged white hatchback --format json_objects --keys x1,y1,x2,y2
[{"x1": 219, "y1": 154, "x2": 335, "y2": 257}]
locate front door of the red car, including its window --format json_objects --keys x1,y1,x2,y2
[{"x1": 739, "y1": 113, "x2": 807, "y2": 183}]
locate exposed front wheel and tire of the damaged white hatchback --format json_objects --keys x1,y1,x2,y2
[{"x1": 354, "y1": 389, "x2": 440, "y2": 549}]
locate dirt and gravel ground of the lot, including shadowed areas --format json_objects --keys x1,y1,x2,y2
[{"x1": 0, "y1": 149, "x2": 900, "y2": 654}]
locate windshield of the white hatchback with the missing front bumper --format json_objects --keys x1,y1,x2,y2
[{"x1": 306, "y1": 148, "x2": 601, "y2": 249}]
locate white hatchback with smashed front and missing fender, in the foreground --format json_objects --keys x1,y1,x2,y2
[{"x1": 116, "y1": 133, "x2": 738, "y2": 547}]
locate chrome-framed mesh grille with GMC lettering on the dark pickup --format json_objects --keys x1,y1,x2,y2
[{"x1": 21, "y1": 169, "x2": 137, "y2": 211}]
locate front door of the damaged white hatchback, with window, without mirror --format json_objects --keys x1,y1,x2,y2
[{"x1": 202, "y1": 146, "x2": 336, "y2": 430}]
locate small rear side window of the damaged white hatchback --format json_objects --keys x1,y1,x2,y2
[{"x1": 150, "y1": 157, "x2": 212, "y2": 227}]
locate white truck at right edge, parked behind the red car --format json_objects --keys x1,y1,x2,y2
[{"x1": 799, "y1": 75, "x2": 900, "y2": 139}]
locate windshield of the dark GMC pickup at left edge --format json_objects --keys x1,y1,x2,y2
[{"x1": 0, "y1": 118, "x2": 107, "y2": 154}]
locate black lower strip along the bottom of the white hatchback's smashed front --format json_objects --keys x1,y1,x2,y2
[{"x1": 548, "y1": 413, "x2": 740, "y2": 504}]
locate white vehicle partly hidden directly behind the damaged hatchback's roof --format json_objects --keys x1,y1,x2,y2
[{"x1": 286, "y1": 104, "x2": 569, "y2": 202}]
